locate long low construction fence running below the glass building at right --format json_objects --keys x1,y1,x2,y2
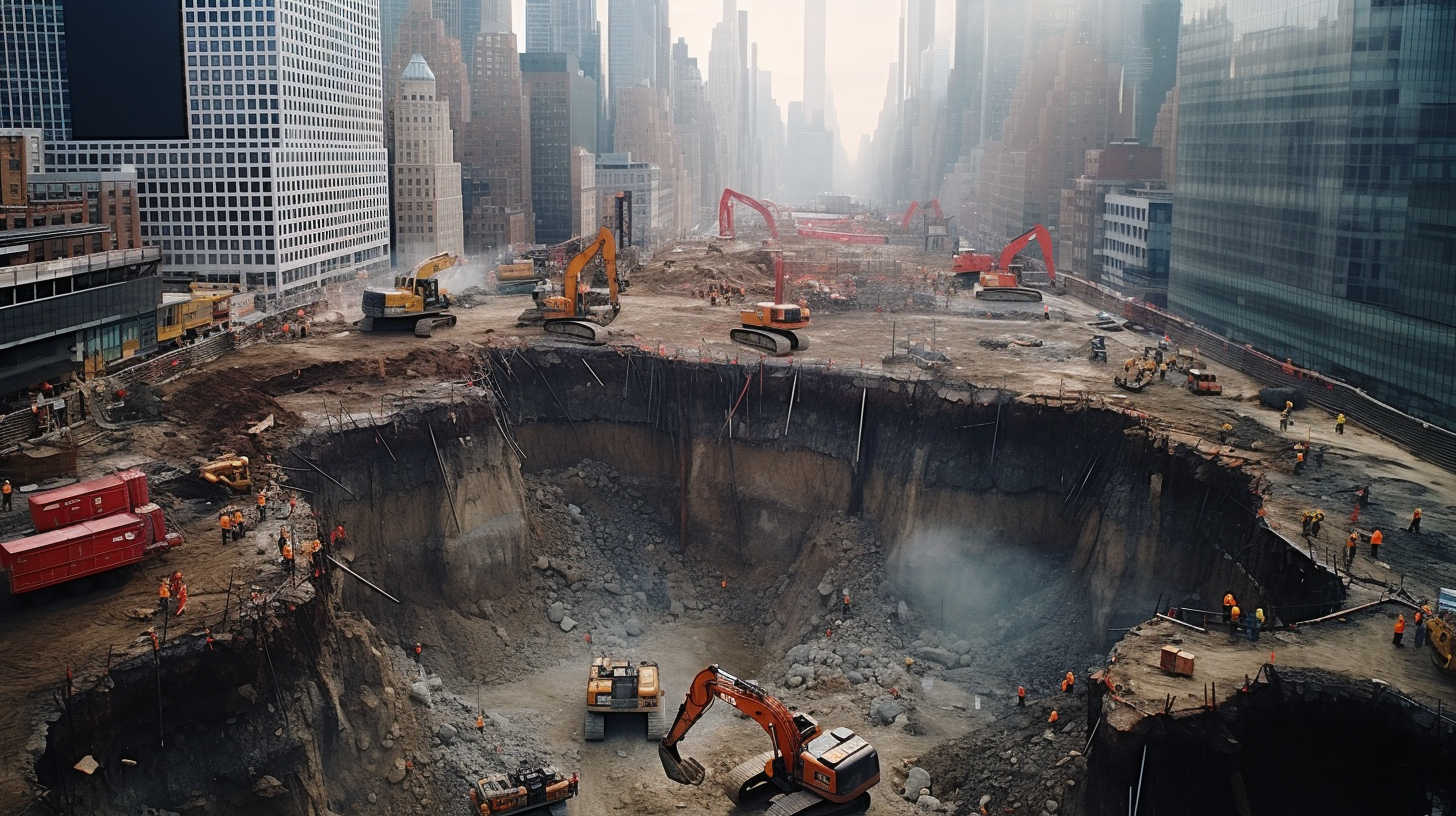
[{"x1": 1057, "y1": 275, "x2": 1456, "y2": 471}]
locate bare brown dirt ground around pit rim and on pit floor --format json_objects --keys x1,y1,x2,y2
[{"x1": 0, "y1": 237, "x2": 1456, "y2": 815}]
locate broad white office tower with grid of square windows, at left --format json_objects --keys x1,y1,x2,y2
[{"x1": 27, "y1": 0, "x2": 389, "y2": 303}]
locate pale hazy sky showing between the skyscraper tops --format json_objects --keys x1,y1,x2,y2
[{"x1": 514, "y1": 0, "x2": 900, "y2": 156}]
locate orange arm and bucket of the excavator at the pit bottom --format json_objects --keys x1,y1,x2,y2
[{"x1": 657, "y1": 663, "x2": 818, "y2": 785}]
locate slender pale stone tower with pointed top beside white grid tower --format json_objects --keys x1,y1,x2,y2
[{"x1": 393, "y1": 54, "x2": 464, "y2": 270}]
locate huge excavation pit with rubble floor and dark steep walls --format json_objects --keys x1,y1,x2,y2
[{"x1": 17, "y1": 350, "x2": 1450, "y2": 813}]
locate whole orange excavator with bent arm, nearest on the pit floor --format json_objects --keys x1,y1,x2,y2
[{"x1": 658, "y1": 664, "x2": 879, "y2": 816}]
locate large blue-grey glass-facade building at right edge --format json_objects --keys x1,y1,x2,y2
[{"x1": 1169, "y1": 0, "x2": 1456, "y2": 428}]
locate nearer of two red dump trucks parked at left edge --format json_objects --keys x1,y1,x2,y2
[{"x1": 0, "y1": 504, "x2": 182, "y2": 603}]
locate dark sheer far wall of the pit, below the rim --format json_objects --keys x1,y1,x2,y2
[{"x1": 492, "y1": 350, "x2": 1341, "y2": 643}]
